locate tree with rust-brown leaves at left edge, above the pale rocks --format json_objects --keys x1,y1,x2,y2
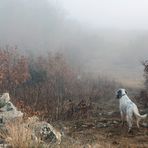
[{"x1": 0, "y1": 48, "x2": 30, "y2": 92}]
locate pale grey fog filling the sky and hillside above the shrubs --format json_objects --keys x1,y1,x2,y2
[{"x1": 0, "y1": 0, "x2": 148, "y2": 87}]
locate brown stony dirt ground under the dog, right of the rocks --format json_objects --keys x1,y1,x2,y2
[{"x1": 55, "y1": 114, "x2": 148, "y2": 148}]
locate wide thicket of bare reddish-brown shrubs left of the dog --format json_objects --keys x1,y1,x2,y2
[{"x1": 0, "y1": 48, "x2": 116, "y2": 121}]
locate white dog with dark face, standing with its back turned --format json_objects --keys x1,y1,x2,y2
[{"x1": 116, "y1": 89, "x2": 147, "y2": 132}]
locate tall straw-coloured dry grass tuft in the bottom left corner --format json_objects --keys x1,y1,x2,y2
[{"x1": 0, "y1": 121, "x2": 42, "y2": 148}]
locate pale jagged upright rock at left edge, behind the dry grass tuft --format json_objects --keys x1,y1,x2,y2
[{"x1": 0, "y1": 93, "x2": 23, "y2": 124}]
